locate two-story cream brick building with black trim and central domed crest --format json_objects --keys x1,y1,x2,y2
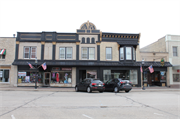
[{"x1": 13, "y1": 22, "x2": 170, "y2": 87}]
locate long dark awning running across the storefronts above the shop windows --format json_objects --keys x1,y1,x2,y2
[{"x1": 12, "y1": 60, "x2": 172, "y2": 67}]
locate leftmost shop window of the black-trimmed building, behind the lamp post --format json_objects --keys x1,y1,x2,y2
[{"x1": 18, "y1": 72, "x2": 43, "y2": 83}]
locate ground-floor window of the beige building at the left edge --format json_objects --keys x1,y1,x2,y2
[{"x1": 0, "y1": 69, "x2": 9, "y2": 82}]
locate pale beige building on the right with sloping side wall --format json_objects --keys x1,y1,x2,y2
[{"x1": 140, "y1": 35, "x2": 180, "y2": 87}]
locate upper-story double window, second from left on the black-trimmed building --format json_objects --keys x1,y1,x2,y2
[{"x1": 59, "y1": 47, "x2": 72, "y2": 59}]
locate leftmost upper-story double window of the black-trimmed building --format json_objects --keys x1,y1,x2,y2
[{"x1": 24, "y1": 47, "x2": 37, "y2": 59}]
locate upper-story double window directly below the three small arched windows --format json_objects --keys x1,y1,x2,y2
[{"x1": 81, "y1": 47, "x2": 95, "y2": 60}]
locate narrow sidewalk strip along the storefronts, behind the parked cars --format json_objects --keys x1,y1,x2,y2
[{"x1": 0, "y1": 87, "x2": 180, "y2": 92}]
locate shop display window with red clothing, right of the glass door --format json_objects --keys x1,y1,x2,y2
[{"x1": 51, "y1": 71, "x2": 72, "y2": 84}]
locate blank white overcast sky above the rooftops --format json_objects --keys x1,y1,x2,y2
[{"x1": 0, "y1": 0, "x2": 180, "y2": 48}]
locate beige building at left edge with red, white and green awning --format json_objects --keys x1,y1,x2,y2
[{"x1": 0, "y1": 37, "x2": 17, "y2": 87}]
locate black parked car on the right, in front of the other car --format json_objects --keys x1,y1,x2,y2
[{"x1": 105, "y1": 78, "x2": 132, "y2": 93}]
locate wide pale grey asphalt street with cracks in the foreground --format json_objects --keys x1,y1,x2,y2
[{"x1": 0, "y1": 91, "x2": 180, "y2": 119}]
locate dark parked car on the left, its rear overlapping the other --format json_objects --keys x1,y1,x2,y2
[{"x1": 75, "y1": 78, "x2": 105, "y2": 93}]
